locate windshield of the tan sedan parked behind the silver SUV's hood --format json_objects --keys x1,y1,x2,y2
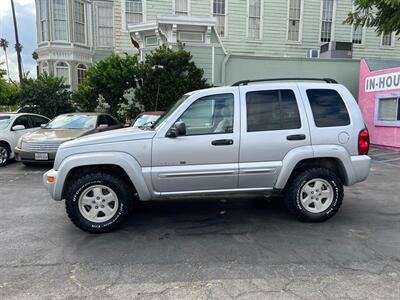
[{"x1": 45, "y1": 115, "x2": 97, "y2": 129}]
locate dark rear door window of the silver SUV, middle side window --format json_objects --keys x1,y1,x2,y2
[{"x1": 246, "y1": 90, "x2": 301, "y2": 132}]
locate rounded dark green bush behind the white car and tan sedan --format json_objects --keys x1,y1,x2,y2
[{"x1": 18, "y1": 73, "x2": 75, "y2": 118}]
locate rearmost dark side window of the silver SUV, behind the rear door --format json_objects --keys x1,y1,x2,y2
[{"x1": 307, "y1": 89, "x2": 350, "y2": 127}]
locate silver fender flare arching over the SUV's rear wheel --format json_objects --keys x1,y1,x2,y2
[{"x1": 275, "y1": 145, "x2": 356, "y2": 190}]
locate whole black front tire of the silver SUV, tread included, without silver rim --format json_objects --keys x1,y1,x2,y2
[{"x1": 65, "y1": 172, "x2": 133, "y2": 233}]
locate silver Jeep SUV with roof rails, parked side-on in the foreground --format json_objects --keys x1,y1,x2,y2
[{"x1": 43, "y1": 79, "x2": 370, "y2": 232}]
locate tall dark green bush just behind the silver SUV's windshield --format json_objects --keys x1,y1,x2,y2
[{"x1": 135, "y1": 45, "x2": 208, "y2": 111}]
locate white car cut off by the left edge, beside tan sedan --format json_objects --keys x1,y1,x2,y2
[{"x1": 0, "y1": 113, "x2": 50, "y2": 167}]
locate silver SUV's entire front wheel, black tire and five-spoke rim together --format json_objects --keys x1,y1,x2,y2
[{"x1": 65, "y1": 172, "x2": 133, "y2": 233}]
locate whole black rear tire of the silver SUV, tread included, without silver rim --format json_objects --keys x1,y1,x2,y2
[{"x1": 284, "y1": 168, "x2": 343, "y2": 222}]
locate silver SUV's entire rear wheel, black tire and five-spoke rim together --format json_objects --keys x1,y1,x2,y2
[{"x1": 285, "y1": 168, "x2": 343, "y2": 222}]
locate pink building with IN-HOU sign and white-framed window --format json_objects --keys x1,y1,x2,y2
[{"x1": 358, "y1": 59, "x2": 400, "y2": 150}]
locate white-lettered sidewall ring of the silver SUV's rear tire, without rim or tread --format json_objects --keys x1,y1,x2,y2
[{"x1": 295, "y1": 173, "x2": 341, "y2": 221}]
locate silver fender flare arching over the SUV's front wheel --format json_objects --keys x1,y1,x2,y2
[{"x1": 54, "y1": 152, "x2": 151, "y2": 200}]
